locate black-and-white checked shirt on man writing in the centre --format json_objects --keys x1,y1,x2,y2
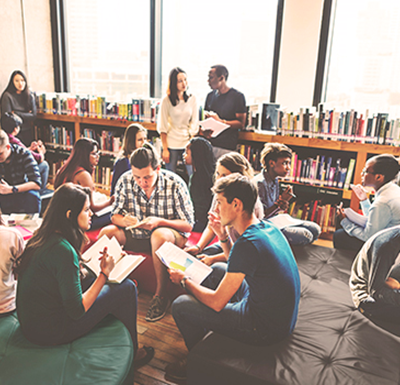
[{"x1": 111, "y1": 170, "x2": 194, "y2": 239}]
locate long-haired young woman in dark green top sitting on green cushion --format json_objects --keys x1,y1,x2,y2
[{"x1": 15, "y1": 183, "x2": 154, "y2": 367}]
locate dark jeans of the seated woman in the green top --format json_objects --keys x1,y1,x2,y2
[{"x1": 58, "y1": 279, "x2": 138, "y2": 353}]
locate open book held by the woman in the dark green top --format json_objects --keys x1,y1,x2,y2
[{"x1": 82, "y1": 235, "x2": 145, "y2": 283}]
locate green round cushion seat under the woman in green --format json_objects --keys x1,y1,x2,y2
[{"x1": 0, "y1": 313, "x2": 133, "y2": 385}]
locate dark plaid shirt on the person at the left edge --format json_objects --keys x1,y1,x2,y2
[{"x1": 0, "y1": 144, "x2": 41, "y2": 186}]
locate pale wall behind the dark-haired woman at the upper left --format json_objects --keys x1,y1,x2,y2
[{"x1": 0, "y1": 0, "x2": 54, "y2": 93}]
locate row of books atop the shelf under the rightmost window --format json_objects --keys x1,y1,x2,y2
[{"x1": 276, "y1": 104, "x2": 400, "y2": 145}]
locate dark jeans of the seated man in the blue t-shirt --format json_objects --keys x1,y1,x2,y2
[{"x1": 172, "y1": 263, "x2": 268, "y2": 350}]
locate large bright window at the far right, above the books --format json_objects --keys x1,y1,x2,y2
[{"x1": 326, "y1": 0, "x2": 400, "y2": 117}]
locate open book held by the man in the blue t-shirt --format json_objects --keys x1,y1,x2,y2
[{"x1": 156, "y1": 242, "x2": 212, "y2": 284}]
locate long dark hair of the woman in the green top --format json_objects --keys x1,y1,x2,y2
[{"x1": 14, "y1": 183, "x2": 90, "y2": 275}]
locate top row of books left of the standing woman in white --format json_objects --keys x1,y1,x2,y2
[{"x1": 36, "y1": 93, "x2": 160, "y2": 123}]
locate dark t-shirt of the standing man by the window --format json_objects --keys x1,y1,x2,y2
[{"x1": 205, "y1": 88, "x2": 246, "y2": 150}]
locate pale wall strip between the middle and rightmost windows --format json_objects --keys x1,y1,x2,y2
[{"x1": 276, "y1": 0, "x2": 324, "y2": 111}]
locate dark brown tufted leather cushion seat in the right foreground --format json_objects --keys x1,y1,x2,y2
[{"x1": 188, "y1": 245, "x2": 400, "y2": 385}]
